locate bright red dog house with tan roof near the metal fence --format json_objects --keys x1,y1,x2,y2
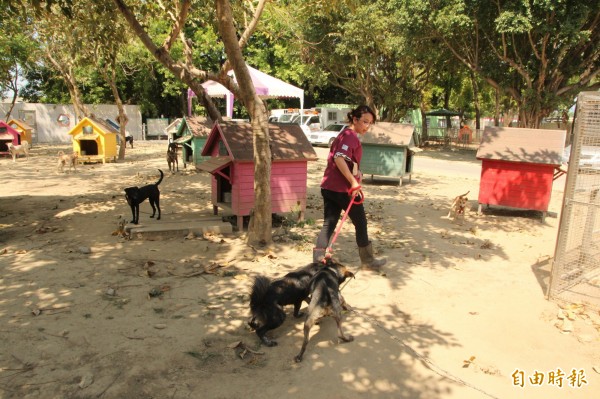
[{"x1": 476, "y1": 127, "x2": 566, "y2": 221}]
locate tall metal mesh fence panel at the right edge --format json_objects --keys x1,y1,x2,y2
[{"x1": 548, "y1": 92, "x2": 600, "y2": 309}]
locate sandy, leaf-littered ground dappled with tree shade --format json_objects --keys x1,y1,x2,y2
[{"x1": 0, "y1": 142, "x2": 600, "y2": 399}]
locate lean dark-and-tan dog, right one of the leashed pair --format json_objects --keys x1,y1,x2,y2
[{"x1": 294, "y1": 260, "x2": 354, "y2": 363}]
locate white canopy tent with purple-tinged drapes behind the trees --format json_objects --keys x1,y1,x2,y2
[{"x1": 188, "y1": 64, "x2": 304, "y2": 118}]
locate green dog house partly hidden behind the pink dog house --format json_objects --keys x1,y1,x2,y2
[{"x1": 173, "y1": 116, "x2": 212, "y2": 167}]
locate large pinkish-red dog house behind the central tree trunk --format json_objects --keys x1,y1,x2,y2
[{"x1": 196, "y1": 121, "x2": 317, "y2": 229}]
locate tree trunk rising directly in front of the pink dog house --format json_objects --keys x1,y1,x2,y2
[{"x1": 215, "y1": 0, "x2": 272, "y2": 246}]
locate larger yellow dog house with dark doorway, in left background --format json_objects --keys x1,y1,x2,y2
[{"x1": 69, "y1": 116, "x2": 119, "y2": 163}]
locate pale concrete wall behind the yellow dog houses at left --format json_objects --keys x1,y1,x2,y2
[{"x1": 0, "y1": 102, "x2": 142, "y2": 144}]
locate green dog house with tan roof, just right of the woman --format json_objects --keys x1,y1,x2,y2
[{"x1": 360, "y1": 122, "x2": 419, "y2": 185}]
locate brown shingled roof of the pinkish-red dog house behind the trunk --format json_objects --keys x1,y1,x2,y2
[{"x1": 202, "y1": 121, "x2": 317, "y2": 161}]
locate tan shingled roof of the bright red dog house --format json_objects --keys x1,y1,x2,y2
[{"x1": 476, "y1": 126, "x2": 566, "y2": 165}]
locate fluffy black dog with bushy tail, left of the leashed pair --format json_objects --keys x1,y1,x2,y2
[{"x1": 248, "y1": 263, "x2": 323, "y2": 346}]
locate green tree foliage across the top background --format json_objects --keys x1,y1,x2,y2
[{"x1": 0, "y1": 0, "x2": 600, "y2": 124}]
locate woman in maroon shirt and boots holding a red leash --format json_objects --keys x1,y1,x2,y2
[{"x1": 313, "y1": 105, "x2": 386, "y2": 270}]
